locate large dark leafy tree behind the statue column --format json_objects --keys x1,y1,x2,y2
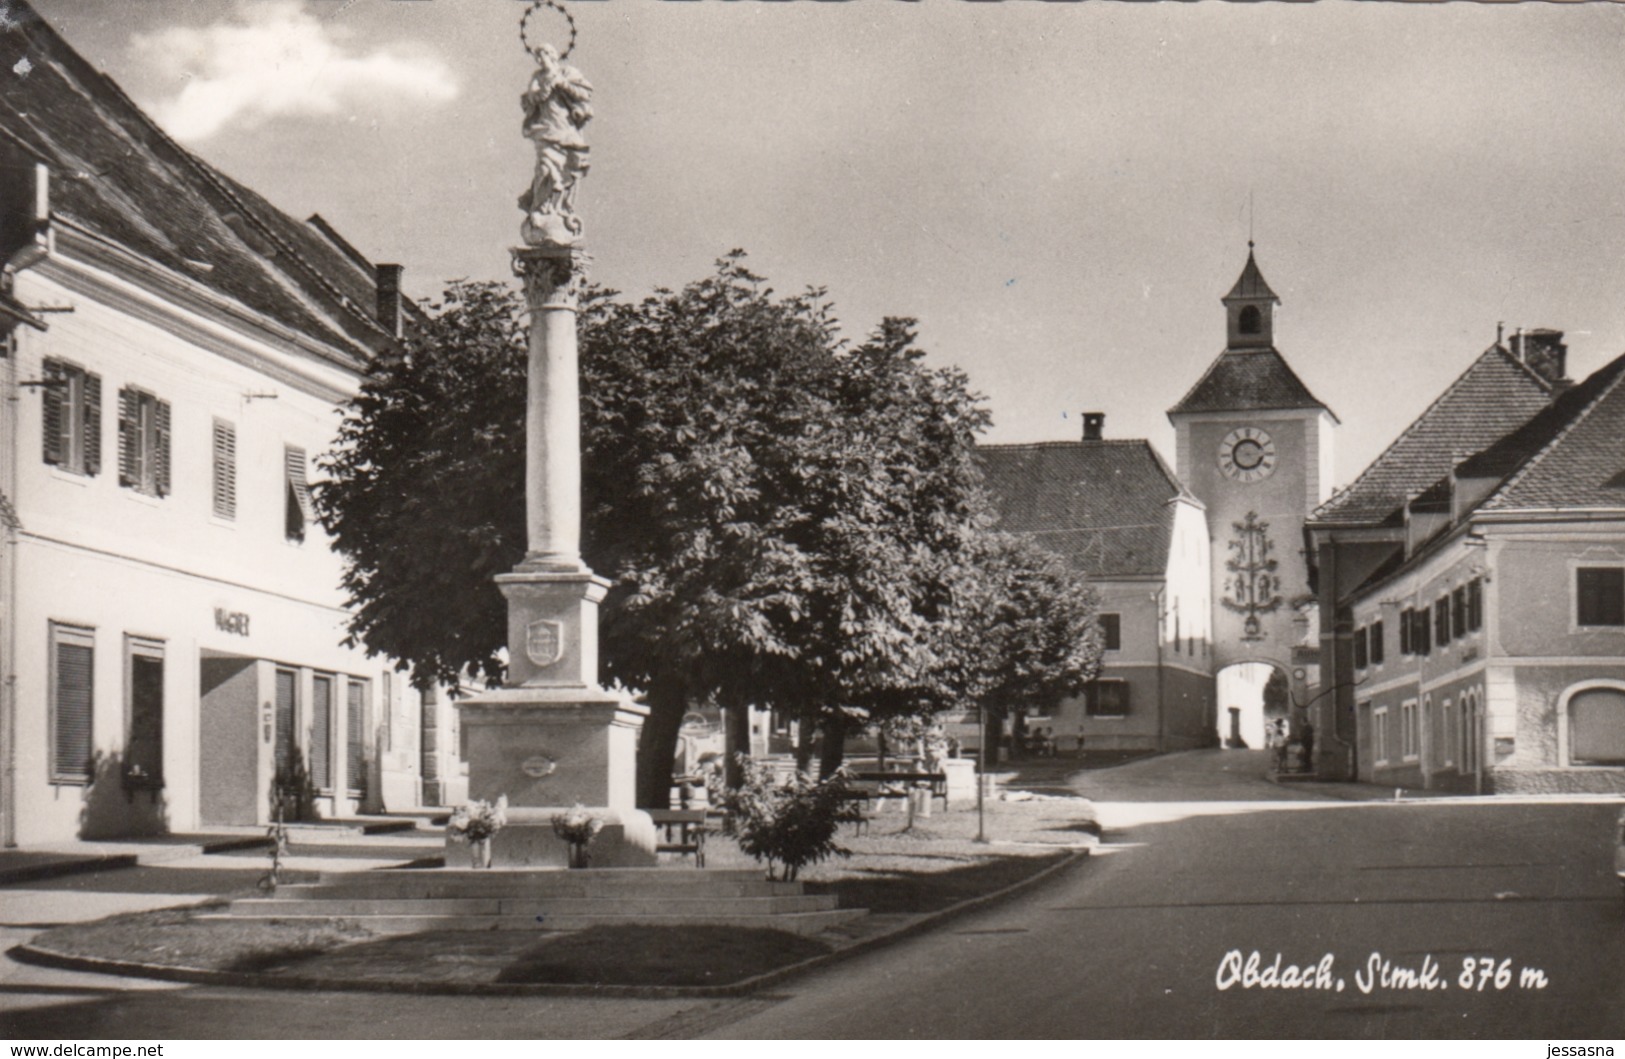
[{"x1": 320, "y1": 253, "x2": 986, "y2": 804}]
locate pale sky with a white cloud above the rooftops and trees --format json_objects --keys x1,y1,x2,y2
[{"x1": 19, "y1": 0, "x2": 1625, "y2": 484}]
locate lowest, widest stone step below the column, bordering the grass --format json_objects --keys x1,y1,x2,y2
[{"x1": 231, "y1": 892, "x2": 837, "y2": 919}]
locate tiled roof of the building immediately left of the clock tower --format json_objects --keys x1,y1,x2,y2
[{"x1": 977, "y1": 440, "x2": 1188, "y2": 578}]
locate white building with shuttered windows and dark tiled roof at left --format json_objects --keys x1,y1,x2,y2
[{"x1": 0, "y1": 10, "x2": 458, "y2": 848}]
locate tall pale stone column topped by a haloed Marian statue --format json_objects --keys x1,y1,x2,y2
[{"x1": 458, "y1": 3, "x2": 655, "y2": 867}]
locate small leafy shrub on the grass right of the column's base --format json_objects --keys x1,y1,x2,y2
[{"x1": 715, "y1": 754, "x2": 848, "y2": 882}]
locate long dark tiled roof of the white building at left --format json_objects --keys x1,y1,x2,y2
[{"x1": 0, "y1": 0, "x2": 388, "y2": 365}]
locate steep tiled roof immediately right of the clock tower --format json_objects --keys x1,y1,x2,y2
[{"x1": 1313, "y1": 346, "x2": 1552, "y2": 523}]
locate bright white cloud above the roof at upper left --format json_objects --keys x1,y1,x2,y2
[{"x1": 130, "y1": 0, "x2": 458, "y2": 143}]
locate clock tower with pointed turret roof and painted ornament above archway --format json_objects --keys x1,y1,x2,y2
[{"x1": 1168, "y1": 242, "x2": 1337, "y2": 675}]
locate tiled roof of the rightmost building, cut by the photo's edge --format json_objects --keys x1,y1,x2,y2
[{"x1": 1482, "y1": 356, "x2": 1625, "y2": 512}]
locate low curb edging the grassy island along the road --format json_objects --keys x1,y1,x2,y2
[{"x1": 7, "y1": 846, "x2": 1089, "y2": 1001}]
